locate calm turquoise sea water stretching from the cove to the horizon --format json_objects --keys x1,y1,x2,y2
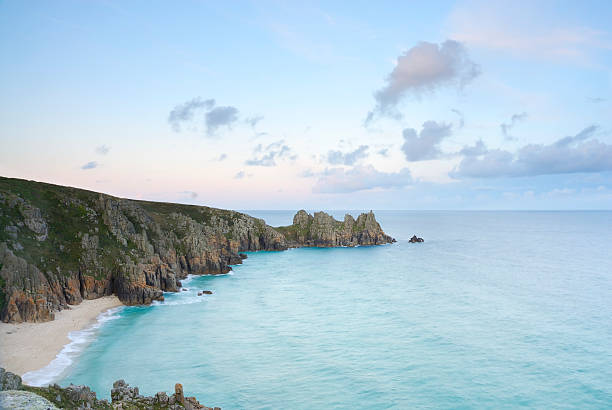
[{"x1": 61, "y1": 211, "x2": 612, "y2": 409}]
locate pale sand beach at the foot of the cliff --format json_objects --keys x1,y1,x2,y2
[{"x1": 0, "y1": 296, "x2": 121, "y2": 375}]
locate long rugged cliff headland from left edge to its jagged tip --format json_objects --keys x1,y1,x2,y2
[{"x1": 0, "y1": 177, "x2": 393, "y2": 323}]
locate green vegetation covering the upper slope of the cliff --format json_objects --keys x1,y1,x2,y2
[{"x1": 0, "y1": 173, "x2": 256, "y2": 279}]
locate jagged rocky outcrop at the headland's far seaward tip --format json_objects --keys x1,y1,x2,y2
[{"x1": 277, "y1": 210, "x2": 395, "y2": 247}]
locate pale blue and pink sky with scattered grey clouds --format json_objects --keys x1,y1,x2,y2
[{"x1": 0, "y1": 0, "x2": 612, "y2": 210}]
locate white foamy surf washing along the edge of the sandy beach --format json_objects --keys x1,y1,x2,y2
[{"x1": 22, "y1": 306, "x2": 123, "y2": 386}]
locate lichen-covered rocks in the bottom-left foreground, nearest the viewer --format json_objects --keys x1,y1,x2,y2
[{"x1": 0, "y1": 368, "x2": 221, "y2": 410}]
